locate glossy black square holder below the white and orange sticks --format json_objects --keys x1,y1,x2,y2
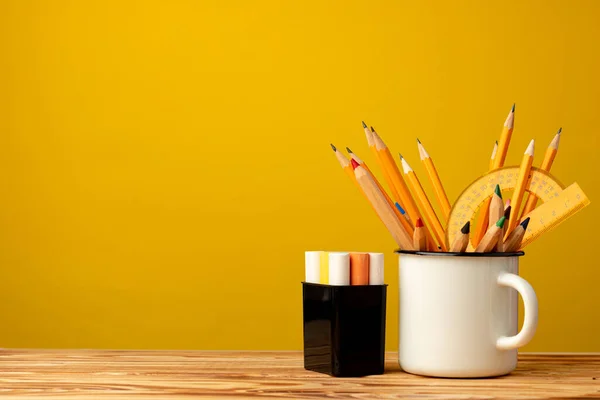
[{"x1": 302, "y1": 282, "x2": 387, "y2": 377}]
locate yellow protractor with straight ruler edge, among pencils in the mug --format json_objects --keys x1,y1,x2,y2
[{"x1": 446, "y1": 166, "x2": 590, "y2": 251}]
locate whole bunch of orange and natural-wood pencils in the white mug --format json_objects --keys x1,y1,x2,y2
[{"x1": 331, "y1": 105, "x2": 576, "y2": 252}]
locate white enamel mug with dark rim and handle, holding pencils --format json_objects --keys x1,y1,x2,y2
[{"x1": 399, "y1": 250, "x2": 538, "y2": 378}]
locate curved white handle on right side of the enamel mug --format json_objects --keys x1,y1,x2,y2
[{"x1": 496, "y1": 272, "x2": 538, "y2": 350}]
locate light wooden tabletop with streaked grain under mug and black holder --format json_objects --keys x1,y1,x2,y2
[{"x1": 0, "y1": 350, "x2": 600, "y2": 400}]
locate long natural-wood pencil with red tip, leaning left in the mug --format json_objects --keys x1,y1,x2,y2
[{"x1": 351, "y1": 160, "x2": 412, "y2": 250}]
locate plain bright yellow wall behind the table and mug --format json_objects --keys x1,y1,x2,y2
[{"x1": 0, "y1": 0, "x2": 600, "y2": 351}]
